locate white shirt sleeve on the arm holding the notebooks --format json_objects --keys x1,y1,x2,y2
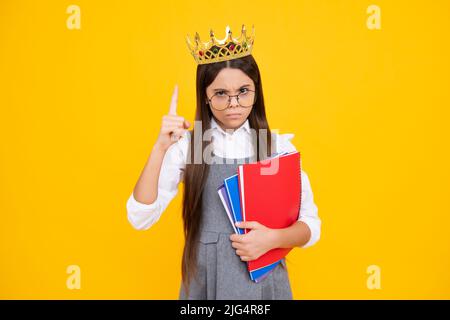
[{"x1": 277, "y1": 134, "x2": 322, "y2": 248}]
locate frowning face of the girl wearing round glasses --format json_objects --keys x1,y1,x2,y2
[{"x1": 206, "y1": 68, "x2": 255, "y2": 129}]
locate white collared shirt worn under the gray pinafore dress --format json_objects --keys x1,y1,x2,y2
[{"x1": 127, "y1": 117, "x2": 321, "y2": 248}]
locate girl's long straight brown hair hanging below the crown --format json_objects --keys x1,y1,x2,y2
[{"x1": 181, "y1": 55, "x2": 272, "y2": 294}]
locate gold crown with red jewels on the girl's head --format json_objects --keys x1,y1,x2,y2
[{"x1": 186, "y1": 25, "x2": 255, "y2": 64}]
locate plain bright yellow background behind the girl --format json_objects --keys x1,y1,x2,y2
[{"x1": 0, "y1": 0, "x2": 450, "y2": 299}]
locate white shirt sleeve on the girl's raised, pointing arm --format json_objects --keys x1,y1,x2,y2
[{"x1": 126, "y1": 131, "x2": 189, "y2": 230}]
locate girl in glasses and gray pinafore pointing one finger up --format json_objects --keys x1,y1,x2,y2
[{"x1": 127, "y1": 25, "x2": 321, "y2": 299}]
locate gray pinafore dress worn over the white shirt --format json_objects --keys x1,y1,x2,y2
[{"x1": 179, "y1": 154, "x2": 292, "y2": 300}]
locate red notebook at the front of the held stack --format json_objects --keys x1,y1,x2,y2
[{"x1": 238, "y1": 151, "x2": 302, "y2": 273}]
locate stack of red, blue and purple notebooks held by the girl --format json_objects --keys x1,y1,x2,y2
[{"x1": 217, "y1": 151, "x2": 301, "y2": 282}]
